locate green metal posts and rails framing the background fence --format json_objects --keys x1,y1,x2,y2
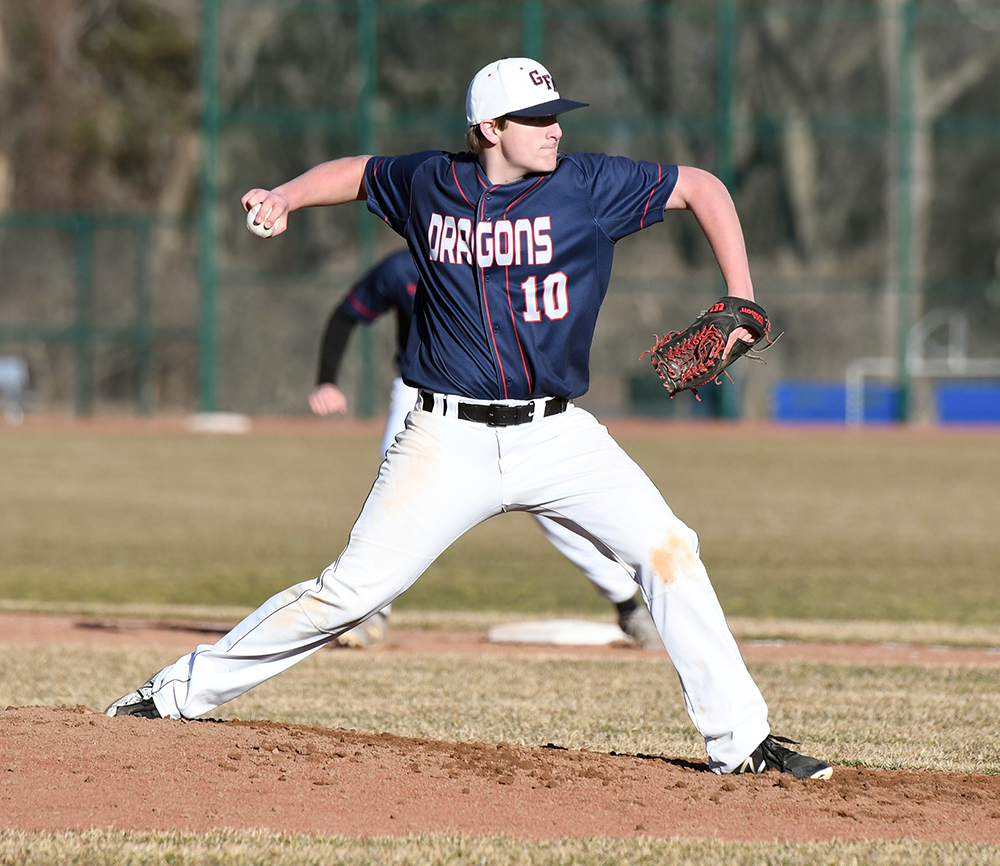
[{"x1": 0, "y1": 0, "x2": 1000, "y2": 418}]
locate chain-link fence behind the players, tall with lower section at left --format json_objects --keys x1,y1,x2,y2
[{"x1": 0, "y1": 0, "x2": 1000, "y2": 418}]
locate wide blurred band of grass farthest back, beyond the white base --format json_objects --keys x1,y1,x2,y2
[{"x1": 0, "y1": 427, "x2": 1000, "y2": 625}]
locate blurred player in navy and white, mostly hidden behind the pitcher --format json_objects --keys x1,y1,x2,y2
[{"x1": 309, "y1": 249, "x2": 663, "y2": 649}]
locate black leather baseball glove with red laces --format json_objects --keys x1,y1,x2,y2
[{"x1": 639, "y1": 296, "x2": 773, "y2": 399}]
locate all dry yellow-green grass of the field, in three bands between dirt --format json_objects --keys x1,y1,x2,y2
[{"x1": 0, "y1": 427, "x2": 1000, "y2": 866}]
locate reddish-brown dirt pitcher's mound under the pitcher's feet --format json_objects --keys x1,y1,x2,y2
[{"x1": 0, "y1": 707, "x2": 1000, "y2": 843}]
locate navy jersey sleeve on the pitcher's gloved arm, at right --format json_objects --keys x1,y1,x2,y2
[{"x1": 570, "y1": 153, "x2": 677, "y2": 241}]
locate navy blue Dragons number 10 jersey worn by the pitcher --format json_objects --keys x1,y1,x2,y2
[{"x1": 365, "y1": 151, "x2": 677, "y2": 400}]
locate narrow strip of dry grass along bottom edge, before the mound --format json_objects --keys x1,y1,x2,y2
[{"x1": 0, "y1": 831, "x2": 996, "y2": 866}]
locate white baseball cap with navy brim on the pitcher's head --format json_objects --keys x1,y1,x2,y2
[{"x1": 465, "y1": 57, "x2": 588, "y2": 126}]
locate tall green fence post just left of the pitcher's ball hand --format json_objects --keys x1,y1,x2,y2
[{"x1": 198, "y1": 0, "x2": 219, "y2": 412}]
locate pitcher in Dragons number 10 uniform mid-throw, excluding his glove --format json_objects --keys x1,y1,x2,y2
[{"x1": 107, "y1": 57, "x2": 833, "y2": 779}]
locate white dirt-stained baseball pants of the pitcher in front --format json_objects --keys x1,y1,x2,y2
[{"x1": 153, "y1": 395, "x2": 769, "y2": 772}]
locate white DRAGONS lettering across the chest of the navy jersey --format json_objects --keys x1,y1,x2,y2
[{"x1": 427, "y1": 213, "x2": 553, "y2": 268}]
